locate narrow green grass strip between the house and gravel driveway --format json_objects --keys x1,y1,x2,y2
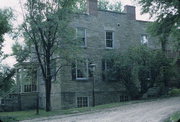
[{"x1": 0, "y1": 98, "x2": 177, "y2": 122}]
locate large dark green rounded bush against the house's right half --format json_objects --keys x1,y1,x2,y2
[{"x1": 105, "y1": 45, "x2": 179, "y2": 99}]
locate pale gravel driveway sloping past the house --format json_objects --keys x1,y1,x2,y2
[{"x1": 23, "y1": 97, "x2": 180, "y2": 122}]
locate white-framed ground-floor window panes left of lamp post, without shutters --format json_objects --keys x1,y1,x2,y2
[{"x1": 76, "y1": 59, "x2": 88, "y2": 80}]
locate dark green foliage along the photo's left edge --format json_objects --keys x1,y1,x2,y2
[{"x1": 0, "y1": 9, "x2": 14, "y2": 95}]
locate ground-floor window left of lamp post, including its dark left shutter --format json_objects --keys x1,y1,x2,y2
[{"x1": 72, "y1": 59, "x2": 89, "y2": 80}]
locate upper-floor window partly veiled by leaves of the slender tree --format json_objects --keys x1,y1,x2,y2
[{"x1": 76, "y1": 28, "x2": 86, "y2": 47}]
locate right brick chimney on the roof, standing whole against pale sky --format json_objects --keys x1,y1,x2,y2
[{"x1": 124, "y1": 5, "x2": 136, "y2": 20}]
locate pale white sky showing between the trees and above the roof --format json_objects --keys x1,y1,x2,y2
[{"x1": 0, "y1": 0, "x2": 149, "y2": 67}]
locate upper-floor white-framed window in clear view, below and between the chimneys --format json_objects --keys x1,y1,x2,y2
[{"x1": 106, "y1": 31, "x2": 113, "y2": 49}]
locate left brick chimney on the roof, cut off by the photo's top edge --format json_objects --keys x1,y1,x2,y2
[{"x1": 87, "y1": 0, "x2": 98, "y2": 16}]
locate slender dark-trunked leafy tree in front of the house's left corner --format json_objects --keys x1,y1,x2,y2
[{"x1": 22, "y1": 0, "x2": 76, "y2": 111}]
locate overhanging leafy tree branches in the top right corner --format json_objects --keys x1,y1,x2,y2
[{"x1": 139, "y1": 0, "x2": 180, "y2": 52}]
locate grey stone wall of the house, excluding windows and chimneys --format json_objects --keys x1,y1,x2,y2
[{"x1": 40, "y1": 7, "x2": 159, "y2": 109}]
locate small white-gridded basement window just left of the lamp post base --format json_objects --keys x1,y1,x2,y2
[{"x1": 77, "y1": 97, "x2": 88, "y2": 108}]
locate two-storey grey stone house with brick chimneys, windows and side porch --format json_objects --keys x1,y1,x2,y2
[{"x1": 0, "y1": 0, "x2": 165, "y2": 109}]
